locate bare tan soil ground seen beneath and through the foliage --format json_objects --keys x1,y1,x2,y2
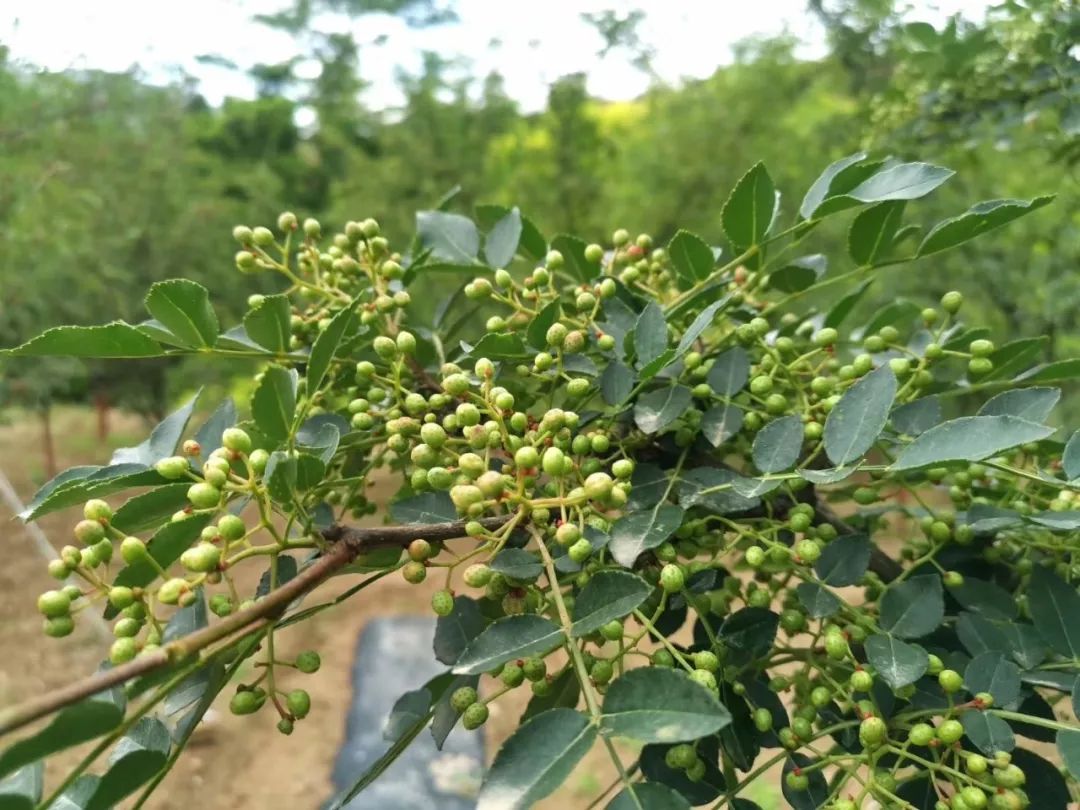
[{"x1": 0, "y1": 408, "x2": 780, "y2": 810}]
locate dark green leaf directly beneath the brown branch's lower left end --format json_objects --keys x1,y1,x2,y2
[{"x1": 0, "y1": 689, "x2": 124, "y2": 779}]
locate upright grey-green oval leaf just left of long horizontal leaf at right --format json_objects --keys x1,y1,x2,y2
[{"x1": 824, "y1": 363, "x2": 896, "y2": 467}]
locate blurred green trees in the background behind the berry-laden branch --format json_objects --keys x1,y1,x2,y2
[{"x1": 0, "y1": 0, "x2": 1080, "y2": 460}]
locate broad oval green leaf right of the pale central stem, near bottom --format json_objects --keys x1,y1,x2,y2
[{"x1": 600, "y1": 666, "x2": 731, "y2": 743}]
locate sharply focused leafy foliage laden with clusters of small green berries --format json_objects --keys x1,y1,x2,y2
[{"x1": 0, "y1": 153, "x2": 1080, "y2": 810}]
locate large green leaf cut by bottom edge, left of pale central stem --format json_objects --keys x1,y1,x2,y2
[{"x1": 476, "y1": 708, "x2": 596, "y2": 810}]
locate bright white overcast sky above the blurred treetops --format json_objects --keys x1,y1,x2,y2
[{"x1": 0, "y1": 0, "x2": 988, "y2": 109}]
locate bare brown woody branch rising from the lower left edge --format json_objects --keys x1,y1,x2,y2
[{"x1": 0, "y1": 517, "x2": 509, "y2": 735}]
